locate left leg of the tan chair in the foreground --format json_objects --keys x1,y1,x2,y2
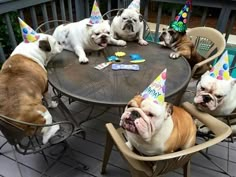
[{"x1": 101, "y1": 132, "x2": 114, "y2": 174}]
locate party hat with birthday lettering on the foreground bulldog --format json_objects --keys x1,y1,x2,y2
[{"x1": 141, "y1": 69, "x2": 167, "y2": 104}]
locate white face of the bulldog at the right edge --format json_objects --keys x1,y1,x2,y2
[{"x1": 194, "y1": 71, "x2": 235, "y2": 112}]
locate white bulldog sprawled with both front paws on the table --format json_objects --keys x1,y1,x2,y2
[{"x1": 53, "y1": 18, "x2": 126, "y2": 63}]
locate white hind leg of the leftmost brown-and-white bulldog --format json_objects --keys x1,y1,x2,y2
[{"x1": 38, "y1": 110, "x2": 60, "y2": 144}]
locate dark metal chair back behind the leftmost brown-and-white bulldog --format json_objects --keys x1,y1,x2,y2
[{"x1": 0, "y1": 115, "x2": 74, "y2": 155}]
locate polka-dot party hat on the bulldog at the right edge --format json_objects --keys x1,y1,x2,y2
[{"x1": 209, "y1": 50, "x2": 231, "y2": 80}]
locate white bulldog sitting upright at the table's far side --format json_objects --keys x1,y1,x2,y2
[{"x1": 111, "y1": 8, "x2": 148, "y2": 45}]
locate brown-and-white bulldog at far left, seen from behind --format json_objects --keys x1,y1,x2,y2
[{"x1": 0, "y1": 34, "x2": 63, "y2": 144}]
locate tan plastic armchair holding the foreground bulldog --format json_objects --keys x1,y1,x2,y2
[{"x1": 101, "y1": 102, "x2": 231, "y2": 177}]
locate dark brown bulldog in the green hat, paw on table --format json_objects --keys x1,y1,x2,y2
[{"x1": 159, "y1": 28, "x2": 210, "y2": 78}]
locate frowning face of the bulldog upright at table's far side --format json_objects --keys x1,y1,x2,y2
[{"x1": 117, "y1": 9, "x2": 143, "y2": 33}]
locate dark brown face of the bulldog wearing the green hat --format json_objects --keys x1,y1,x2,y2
[{"x1": 159, "y1": 28, "x2": 185, "y2": 48}]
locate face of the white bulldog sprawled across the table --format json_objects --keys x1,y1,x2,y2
[{"x1": 87, "y1": 20, "x2": 110, "y2": 48}]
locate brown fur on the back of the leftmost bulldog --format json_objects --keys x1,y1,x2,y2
[{"x1": 0, "y1": 55, "x2": 48, "y2": 134}]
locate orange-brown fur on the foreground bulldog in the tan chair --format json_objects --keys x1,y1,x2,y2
[{"x1": 165, "y1": 106, "x2": 197, "y2": 153}]
